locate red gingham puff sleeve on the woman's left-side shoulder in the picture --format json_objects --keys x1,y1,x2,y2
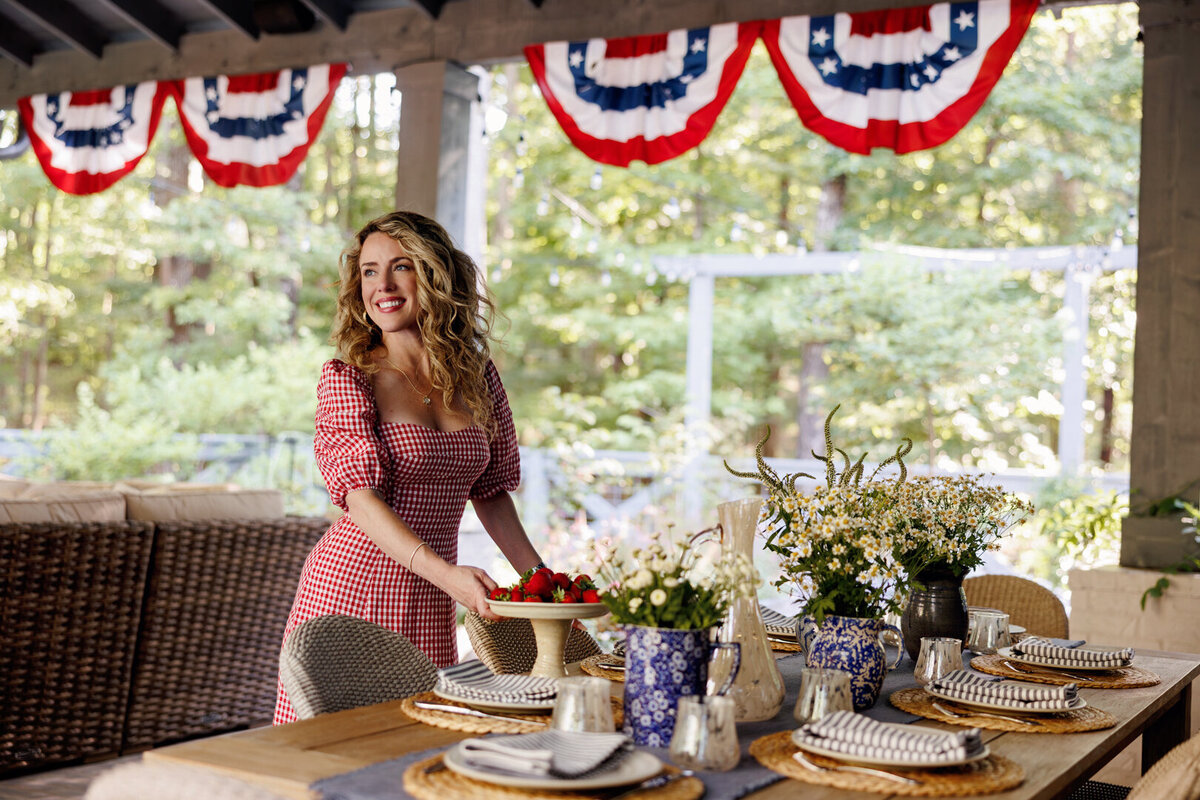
[{"x1": 313, "y1": 359, "x2": 384, "y2": 511}]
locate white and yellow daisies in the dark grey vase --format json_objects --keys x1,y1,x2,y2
[{"x1": 893, "y1": 475, "x2": 1033, "y2": 577}]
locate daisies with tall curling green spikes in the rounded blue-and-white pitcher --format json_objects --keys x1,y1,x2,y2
[{"x1": 725, "y1": 408, "x2": 912, "y2": 624}]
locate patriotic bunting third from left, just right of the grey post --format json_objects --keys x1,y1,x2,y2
[{"x1": 526, "y1": 23, "x2": 761, "y2": 167}]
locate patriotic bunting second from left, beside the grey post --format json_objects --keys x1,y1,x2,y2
[{"x1": 172, "y1": 64, "x2": 346, "y2": 186}]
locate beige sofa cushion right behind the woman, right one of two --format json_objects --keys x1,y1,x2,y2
[{"x1": 125, "y1": 485, "x2": 284, "y2": 522}]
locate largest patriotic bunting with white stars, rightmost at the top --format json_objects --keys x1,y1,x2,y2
[{"x1": 763, "y1": 0, "x2": 1038, "y2": 154}]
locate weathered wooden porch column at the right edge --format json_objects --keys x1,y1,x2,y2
[{"x1": 1121, "y1": 0, "x2": 1200, "y2": 567}]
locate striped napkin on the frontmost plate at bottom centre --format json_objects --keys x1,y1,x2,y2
[{"x1": 460, "y1": 730, "x2": 634, "y2": 778}]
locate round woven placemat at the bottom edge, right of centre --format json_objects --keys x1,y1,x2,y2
[{"x1": 750, "y1": 730, "x2": 1025, "y2": 798}]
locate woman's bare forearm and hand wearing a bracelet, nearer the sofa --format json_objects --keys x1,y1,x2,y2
[{"x1": 346, "y1": 489, "x2": 501, "y2": 620}]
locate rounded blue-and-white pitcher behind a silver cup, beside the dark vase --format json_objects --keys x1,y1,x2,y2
[{"x1": 796, "y1": 615, "x2": 904, "y2": 710}]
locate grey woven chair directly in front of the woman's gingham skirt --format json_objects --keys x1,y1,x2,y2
[{"x1": 280, "y1": 614, "x2": 438, "y2": 720}]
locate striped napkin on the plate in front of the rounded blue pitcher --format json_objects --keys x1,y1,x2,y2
[{"x1": 792, "y1": 711, "x2": 984, "y2": 764}]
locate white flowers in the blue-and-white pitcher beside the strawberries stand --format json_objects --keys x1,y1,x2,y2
[{"x1": 599, "y1": 535, "x2": 755, "y2": 630}]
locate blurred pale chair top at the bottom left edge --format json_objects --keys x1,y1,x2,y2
[{"x1": 83, "y1": 762, "x2": 283, "y2": 800}]
